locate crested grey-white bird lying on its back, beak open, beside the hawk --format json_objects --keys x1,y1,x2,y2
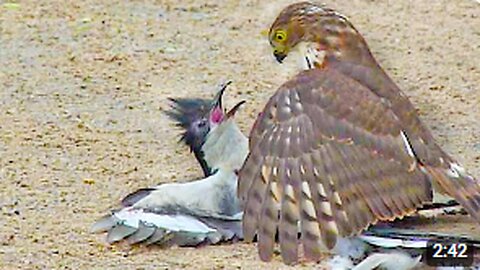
[{"x1": 91, "y1": 82, "x2": 248, "y2": 246}]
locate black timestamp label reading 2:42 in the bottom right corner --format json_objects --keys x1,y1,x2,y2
[{"x1": 425, "y1": 241, "x2": 475, "y2": 267}]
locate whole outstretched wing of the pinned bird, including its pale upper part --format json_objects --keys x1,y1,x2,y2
[{"x1": 91, "y1": 172, "x2": 243, "y2": 246}]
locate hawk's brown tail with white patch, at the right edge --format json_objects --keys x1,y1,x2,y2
[{"x1": 425, "y1": 167, "x2": 480, "y2": 223}]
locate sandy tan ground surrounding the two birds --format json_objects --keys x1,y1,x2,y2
[{"x1": 0, "y1": 0, "x2": 480, "y2": 269}]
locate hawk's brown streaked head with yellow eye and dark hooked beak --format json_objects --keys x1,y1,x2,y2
[{"x1": 269, "y1": 2, "x2": 368, "y2": 69}]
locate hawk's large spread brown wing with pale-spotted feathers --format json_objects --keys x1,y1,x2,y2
[{"x1": 239, "y1": 68, "x2": 431, "y2": 263}]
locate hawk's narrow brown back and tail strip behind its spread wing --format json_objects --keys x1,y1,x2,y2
[{"x1": 328, "y1": 59, "x2": 480, "y2": 226}]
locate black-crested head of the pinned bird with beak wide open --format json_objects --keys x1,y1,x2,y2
[{"x1": 165, "y1": 81, "x2": 245, "y2": 176}]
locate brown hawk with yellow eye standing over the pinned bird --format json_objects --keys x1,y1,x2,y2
[{"x1": 238, "y1": 2, "x2": 480, "y2": 264}]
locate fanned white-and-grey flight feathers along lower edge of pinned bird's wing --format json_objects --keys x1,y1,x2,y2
[{"x1": 91, "y1": 208, "x2": 242, "y2": 247}]
